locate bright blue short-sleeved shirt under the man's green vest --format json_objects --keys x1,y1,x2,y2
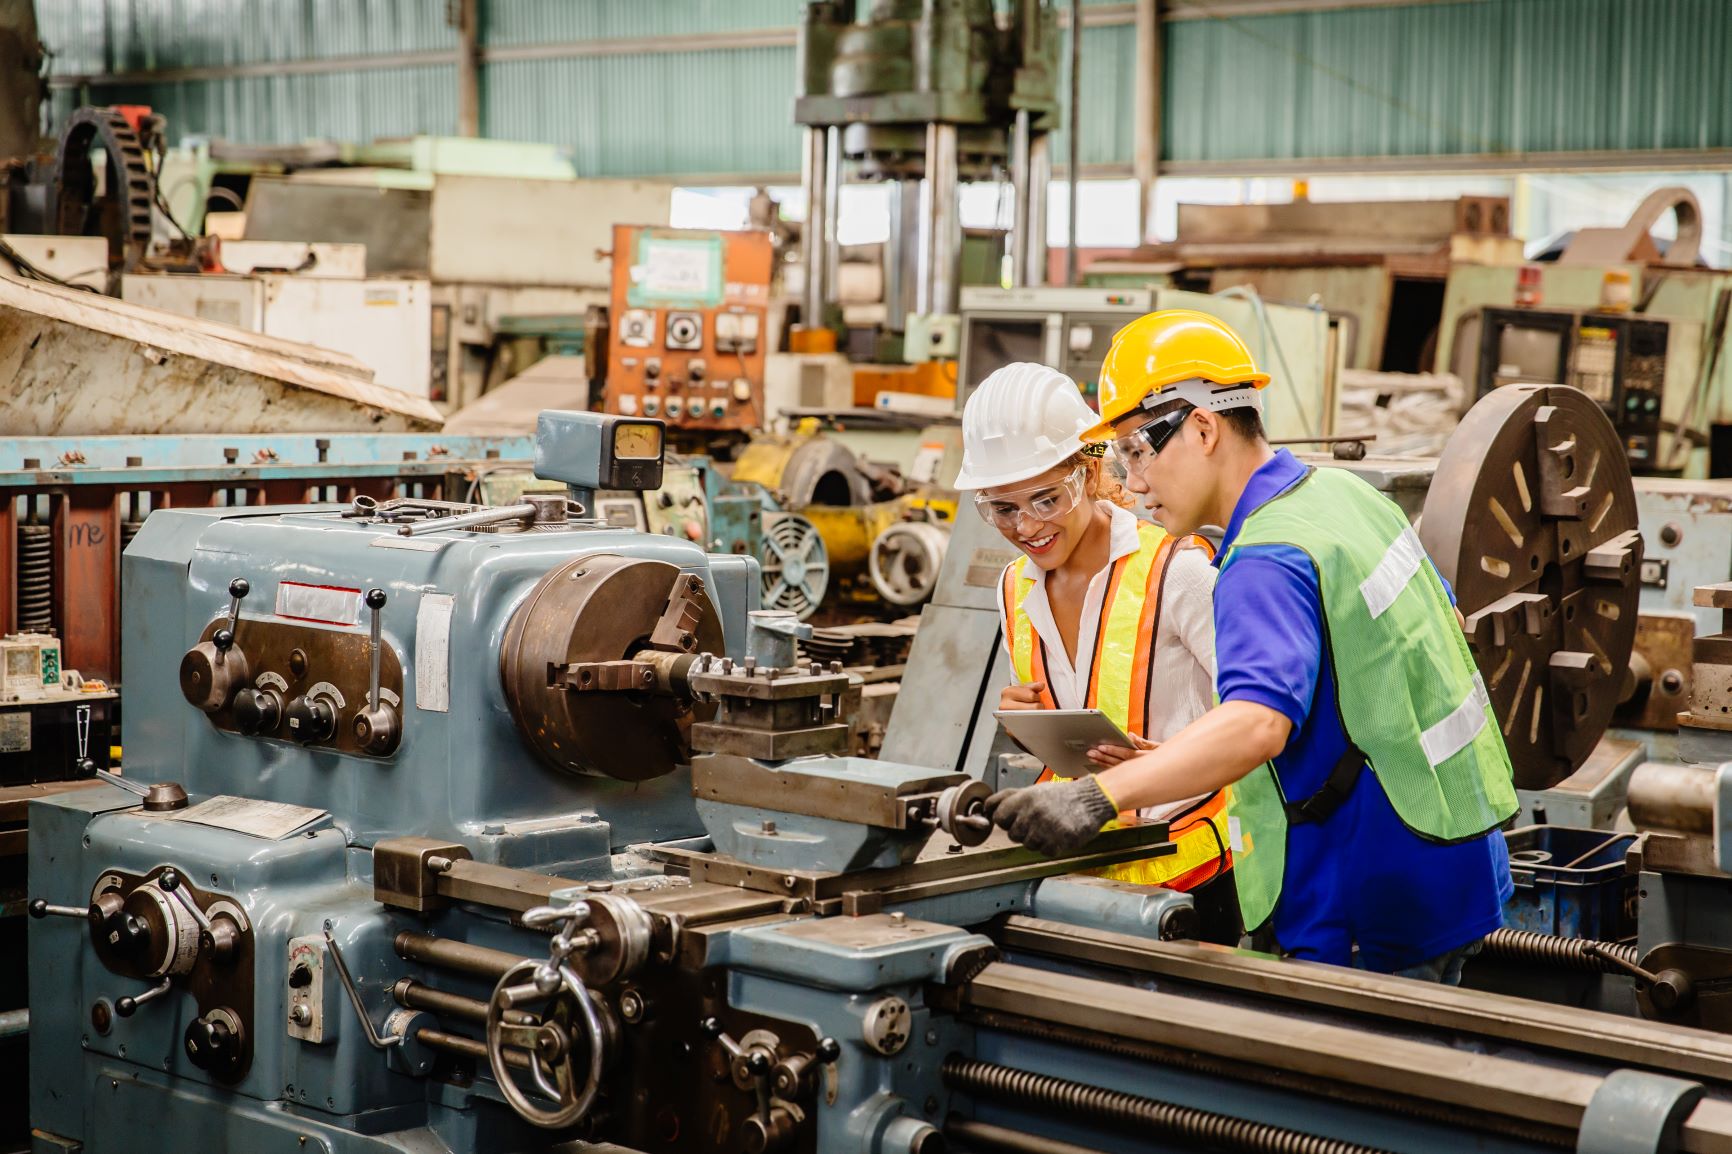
[{"x1": 1214, "y1": 449, "x2": 1514, "y2": 972}]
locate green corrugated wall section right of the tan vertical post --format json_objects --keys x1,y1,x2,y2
[{"x1": 1164, "y1": 0, "x2": 1732, "y2": 163}]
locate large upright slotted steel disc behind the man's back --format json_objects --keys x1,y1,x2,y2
[{"x1": 1419, "y1": 385, "x2": 1642, "y2": 790}]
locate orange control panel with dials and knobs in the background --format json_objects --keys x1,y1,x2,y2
[{"x1": 603, "y1": 225, "x2": 774, "y2": 431}]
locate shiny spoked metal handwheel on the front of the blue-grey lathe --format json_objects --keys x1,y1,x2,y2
[{"x1": 487, "y1": 903, "x2": 606, "y2": 1130}]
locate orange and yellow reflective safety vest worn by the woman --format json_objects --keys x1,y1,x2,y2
[{"x1": 1005, "y1": 522, "x2": 1233, "y2": 891}]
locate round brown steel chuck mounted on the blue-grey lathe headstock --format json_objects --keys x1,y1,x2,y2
[{"x1": 499, "y1": 556, "x2": 722, "y2": 781}]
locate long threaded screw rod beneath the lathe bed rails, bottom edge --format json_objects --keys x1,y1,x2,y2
[{"x1": 944, "y1": 1054, "x2": 1380, "y2": 1154}]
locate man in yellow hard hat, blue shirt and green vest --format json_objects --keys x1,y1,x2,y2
[{"x1": 987, "y1": 310, "x2": 1517, "y2": 984}]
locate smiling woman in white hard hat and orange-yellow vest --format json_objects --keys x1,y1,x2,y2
[{"x1": 956, "y1": 364, "x2": 1240, "y2": 944}]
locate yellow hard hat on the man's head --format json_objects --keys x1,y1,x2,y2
[{"x1": 1088, "y1": 308, "x2": 1270, "y2": 440}]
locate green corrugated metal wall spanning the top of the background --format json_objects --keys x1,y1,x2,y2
[{"x1": 38, "y1": 0, "x2": 1732, "y2": 180}]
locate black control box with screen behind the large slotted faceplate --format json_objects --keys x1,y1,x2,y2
[{"x1": 1477, "y1": 308, "x2": 1671, "y2": 473}]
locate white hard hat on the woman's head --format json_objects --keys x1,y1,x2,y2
[{"x1": 956, "y1": 360, "x2": 1100, "y2": 489}]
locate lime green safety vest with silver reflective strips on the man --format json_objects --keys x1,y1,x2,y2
[{"x1": 1221, "y1": 468, "x2": 1517, "y2": 930}]
